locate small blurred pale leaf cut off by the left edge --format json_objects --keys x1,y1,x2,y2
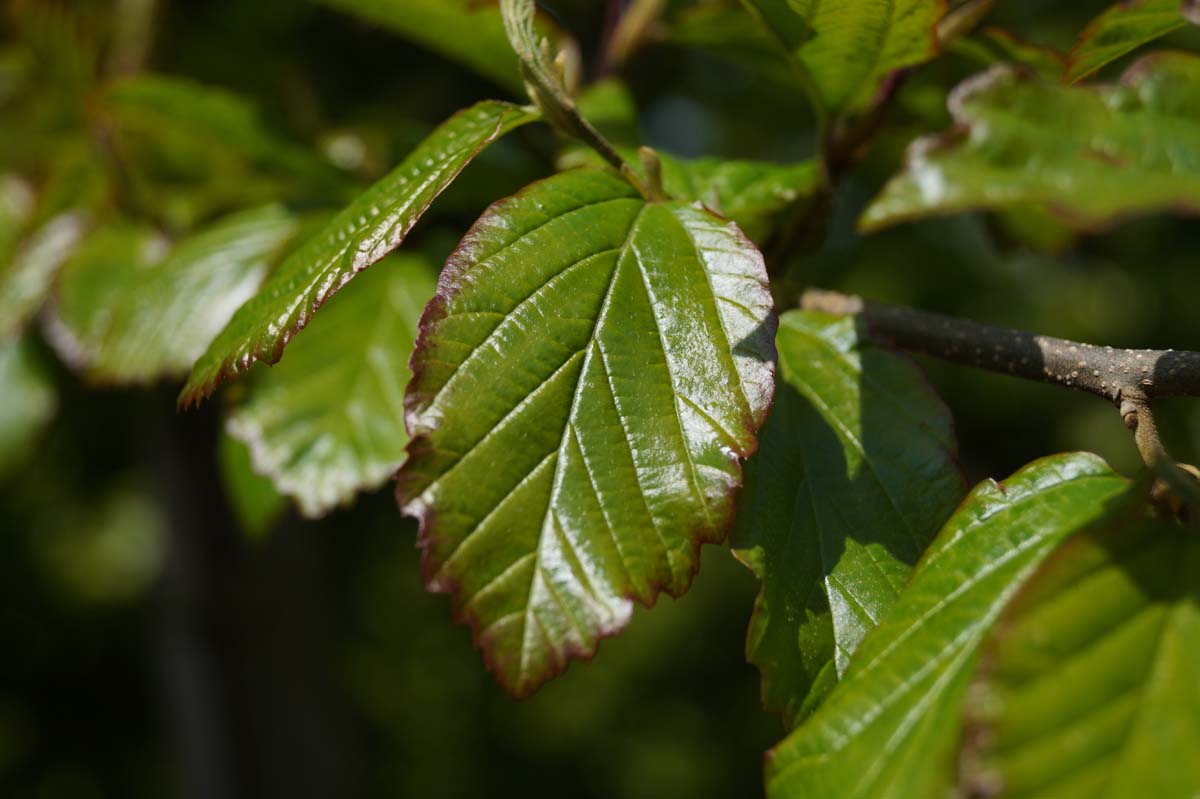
[{"x1": 0, "y1": 211, "x2": 88, "y2": 342}]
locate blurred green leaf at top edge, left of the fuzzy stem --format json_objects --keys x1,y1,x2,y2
[{"x1": 320, "y1": 0, "x2": 546, "y2": 95}]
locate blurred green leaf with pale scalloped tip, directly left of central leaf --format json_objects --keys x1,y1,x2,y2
[{"x1": 228, "y1": 256, "x2": 434, "y2": 517}]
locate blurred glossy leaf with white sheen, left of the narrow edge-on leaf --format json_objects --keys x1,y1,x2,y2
[{"x1": 52, "y1": 205, "x2": 301, "y2": 383}]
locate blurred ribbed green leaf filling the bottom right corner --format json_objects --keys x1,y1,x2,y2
[{"x1": 962, "y1": 513, "x2": 1200, "y2": 799}]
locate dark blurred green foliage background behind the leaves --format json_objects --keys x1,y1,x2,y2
[{"x1": 0, "y1": 0, "x2": 1200, "y2": 799}]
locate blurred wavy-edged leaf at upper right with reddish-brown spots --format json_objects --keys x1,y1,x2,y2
[{"x1": 859, "y1": 53, "x2": 1200, "y2": 232}]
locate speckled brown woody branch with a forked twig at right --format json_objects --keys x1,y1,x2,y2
[{"x1": 800, "y1": 290, "x2": 1200, "y2": 475}]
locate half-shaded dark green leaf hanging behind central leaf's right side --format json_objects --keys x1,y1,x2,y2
[{"x1": 733, "y1": 311, "x2": 965, "y2": 726}]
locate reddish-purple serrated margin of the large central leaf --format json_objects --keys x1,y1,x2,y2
[{"x1": 394, "y1": 167, "x2": 779, "y2": 699}]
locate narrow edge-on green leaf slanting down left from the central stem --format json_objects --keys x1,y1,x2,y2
[{"x1": 179, "y1": 101, "x2": 536, "y2": 405}]
